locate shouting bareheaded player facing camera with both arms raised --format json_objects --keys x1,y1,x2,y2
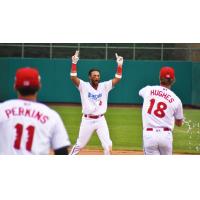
[{"x1": 70, "y1": 51, "x2": 123, "y2": 155}]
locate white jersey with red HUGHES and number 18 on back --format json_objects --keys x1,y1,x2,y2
[{"x1": 139, "y1": 86, "x2": 183, "y2": 130}]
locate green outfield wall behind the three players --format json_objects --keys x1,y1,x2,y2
[{"x1": 0, "y1": 58, "x2": 200, "y2": 105}]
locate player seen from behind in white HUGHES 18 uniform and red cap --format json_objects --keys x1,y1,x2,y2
[{"x1": 139, "y1": 67, "x2": 183, "y2": 155}]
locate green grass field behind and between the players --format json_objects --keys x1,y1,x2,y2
[{"x1": 51, "y1": 105, "x2": 200, "y2": 154}]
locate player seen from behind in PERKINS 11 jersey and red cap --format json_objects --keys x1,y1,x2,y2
[{"x1": 0, "y1": 67, "x2": 70, "y2": 155}]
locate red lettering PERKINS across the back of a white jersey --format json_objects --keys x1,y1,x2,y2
[{"x1": 5, "y1": 107, "x2": 49, "y2": 124}]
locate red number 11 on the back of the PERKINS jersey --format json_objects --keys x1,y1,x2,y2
[{"x1": 14, "y1": 124, "x2": 35, "y2": 151}]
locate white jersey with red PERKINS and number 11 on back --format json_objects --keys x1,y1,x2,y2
[{"x1": 0, "y1": 99, "x2": 70, "y2": 155}]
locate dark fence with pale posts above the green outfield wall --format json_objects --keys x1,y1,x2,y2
[{"x1": 0, "y1": 43, "x2": 200, "y2": 61}]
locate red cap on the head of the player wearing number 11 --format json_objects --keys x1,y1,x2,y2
[{"x1": 15, "y1": 67, "x2": 40, "y2": 89}]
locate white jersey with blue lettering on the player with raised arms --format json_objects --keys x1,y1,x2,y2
[{"x1": 78, "y1": 80, "x2": 112, "y2": 115}]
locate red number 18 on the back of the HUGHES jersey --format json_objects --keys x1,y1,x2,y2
[{"x1": 147, "y1": 99, "x2": 167, "y2": 118}]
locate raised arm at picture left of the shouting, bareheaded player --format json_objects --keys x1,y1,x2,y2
[{"x1": 70, "y1": 51, "x2": 80, "y2": 87}]
